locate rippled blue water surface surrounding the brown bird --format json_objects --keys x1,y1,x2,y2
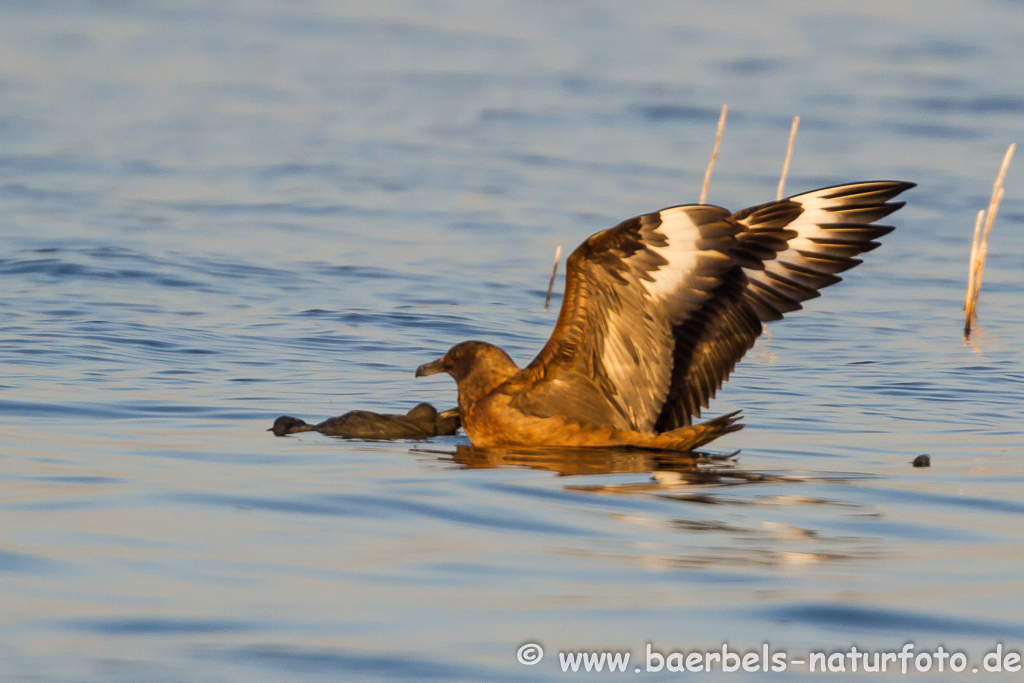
[{"x1": 0, "y1": 0, "x2": 1024, "y2": 682}]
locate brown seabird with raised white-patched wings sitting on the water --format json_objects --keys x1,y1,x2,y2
[{"x1": 416, "y1": 180, "x2": 913, "y2": 451}]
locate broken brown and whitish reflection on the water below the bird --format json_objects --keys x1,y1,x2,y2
[{"x1": 413, "y1": 445, "x2": 882, "y2": 570}]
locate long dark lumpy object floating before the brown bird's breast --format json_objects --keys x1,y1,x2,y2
[{"x1": 267, "y1": 403, "x2": 460, "y2": 439}]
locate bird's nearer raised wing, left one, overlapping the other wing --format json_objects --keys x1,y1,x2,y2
[{"x1": 505, "y1": 206, "x2": 742, "y2": 432}]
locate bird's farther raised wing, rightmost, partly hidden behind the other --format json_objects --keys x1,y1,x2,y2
[{"x1": 655, "y1": 181, "x2": 913, "y2": 431}]
